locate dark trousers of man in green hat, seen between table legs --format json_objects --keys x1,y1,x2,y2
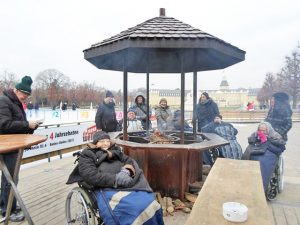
[{"x1": 0, "y1": 152, "x2": 18, "y2": 215}]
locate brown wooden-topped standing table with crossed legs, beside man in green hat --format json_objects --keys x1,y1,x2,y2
[{"x1": 0, "y1": 134, "x2": 47, "y2": 225}]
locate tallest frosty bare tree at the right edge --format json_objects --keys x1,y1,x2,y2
[{"x1": 278, "y1": 47, "x2": 300, "y2": 109}]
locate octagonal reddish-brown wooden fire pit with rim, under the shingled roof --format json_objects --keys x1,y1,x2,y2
[{"x1": 116, "y1": 131, "x2": 228, "y2": 199}]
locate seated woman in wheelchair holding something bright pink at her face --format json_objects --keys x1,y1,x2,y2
[{"x1": 242, "y1": 122, "x2": 286, "y2": 192}]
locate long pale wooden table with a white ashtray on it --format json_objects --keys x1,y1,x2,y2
[{"x1": 185, "y1": 158, "x2": 274, "y2": 225}]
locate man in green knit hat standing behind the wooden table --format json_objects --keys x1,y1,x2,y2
[{"x1": 0, "y1": 76, "x2": 39, "y2": 222}]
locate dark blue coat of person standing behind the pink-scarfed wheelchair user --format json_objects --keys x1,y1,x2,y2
[{"x1": 265, "y1": 101, "x2": 293, "y2": 141}]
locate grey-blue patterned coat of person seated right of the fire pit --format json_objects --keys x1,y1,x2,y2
[{"x1": 202, "y1": 121, "x2": 243, "y2": 159}]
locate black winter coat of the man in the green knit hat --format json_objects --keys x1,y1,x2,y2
[{"x1": 0, "y1": 89, "x2": 34, "y2": 134}]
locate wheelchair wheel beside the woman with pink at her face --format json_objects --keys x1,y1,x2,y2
[{"x1": 266, "y1": 154, "x2": 284, "y2": 201}]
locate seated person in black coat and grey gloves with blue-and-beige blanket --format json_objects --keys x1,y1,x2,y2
[{"x1": 67, "y1": 131, "x2": 164, "y2": 225}]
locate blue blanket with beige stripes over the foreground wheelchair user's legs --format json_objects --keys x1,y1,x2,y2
[{"x1": 96, "y1": 190, "x2": 164, "y2": 225}]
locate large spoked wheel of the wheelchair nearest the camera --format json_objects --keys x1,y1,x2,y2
[{"x1": 65, "y1": 187, "x2": 96, "y2": 225}]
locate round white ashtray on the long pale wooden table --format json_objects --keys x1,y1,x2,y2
[{"x1": 223, "y1": 202, "x2": 248, "y2": 223}]
